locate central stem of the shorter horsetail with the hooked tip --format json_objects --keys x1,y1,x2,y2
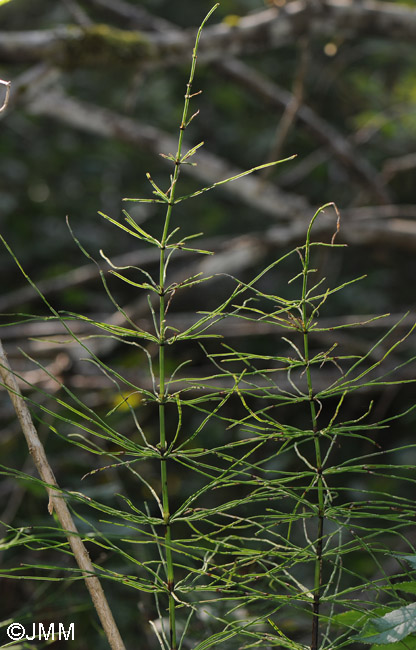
[{"x1": 302, "y1": 210, "x2": 325, "y2": 650}]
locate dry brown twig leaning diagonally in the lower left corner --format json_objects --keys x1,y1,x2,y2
[{"x1": 0, "y1": 341, "x2": 125, "y2": 650}]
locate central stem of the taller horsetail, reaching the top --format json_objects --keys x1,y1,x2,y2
[{"x1": 158, "y1": 5, "x2": 218, "y2": 650}]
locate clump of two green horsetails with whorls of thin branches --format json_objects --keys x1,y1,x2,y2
[{"x1": 1, "y1": 5, "x2": 416, "y2": 650}]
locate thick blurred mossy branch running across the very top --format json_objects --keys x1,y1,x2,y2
[{"x1": 0, "y1": 0, "x2": 416, "y2": 68}]
